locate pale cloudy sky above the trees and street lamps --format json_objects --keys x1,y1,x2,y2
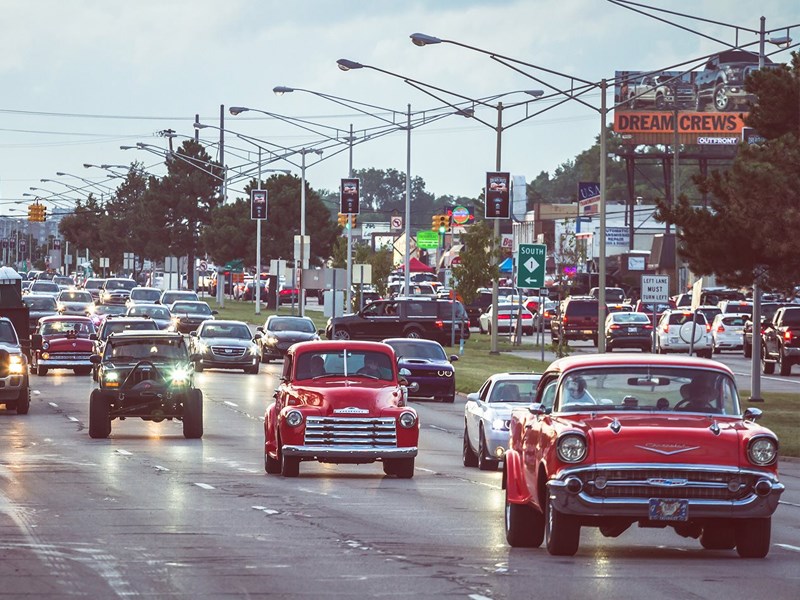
[{"x1": 0, "y1": 0, "x2": 800, "y2": 217}]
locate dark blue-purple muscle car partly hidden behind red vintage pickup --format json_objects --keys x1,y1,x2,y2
[{"x1": 383, "y1": 338, "x2": 458, "y2": 404}]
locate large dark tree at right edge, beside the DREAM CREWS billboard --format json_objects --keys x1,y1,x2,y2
[{"x1": 657, "y1": 53, "x2": 800, "y2": 289}]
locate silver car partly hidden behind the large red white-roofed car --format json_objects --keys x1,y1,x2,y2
[{"x1": 461, "y1": 373, "x2": 541, "y2": 471}]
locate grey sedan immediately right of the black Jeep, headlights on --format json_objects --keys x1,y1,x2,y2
[{"x1": 189, "y1": 319, "x2": 261, "y2": 375}]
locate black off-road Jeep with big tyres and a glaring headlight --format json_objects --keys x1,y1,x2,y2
[{"x1": 89, "y1": 331, "x2": 203, "y2": 439}]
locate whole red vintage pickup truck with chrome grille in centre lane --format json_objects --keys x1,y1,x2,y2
[{"x1": 264, "y1": 341, "x2": 419, "y2": 479}]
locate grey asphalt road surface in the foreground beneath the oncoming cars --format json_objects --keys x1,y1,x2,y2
[{"x1": 0, "y1": 364, "x2": 800, "y2": 600}]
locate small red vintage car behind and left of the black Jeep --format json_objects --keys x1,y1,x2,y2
[{"x1": 31, "y1": 315, "x2": 95, "y2": 375}]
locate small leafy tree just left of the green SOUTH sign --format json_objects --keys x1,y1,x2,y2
[{"x1": 453, "y1": 221, "x2": 500, "y2": 304}]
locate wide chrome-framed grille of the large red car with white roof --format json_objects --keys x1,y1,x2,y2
[{"x1": 579, "y1": 469, "x2": 757, "y2": 501}]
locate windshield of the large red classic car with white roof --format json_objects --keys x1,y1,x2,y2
[{"x1": 554, "y1": 366, "x2": 740, "y2": 416}]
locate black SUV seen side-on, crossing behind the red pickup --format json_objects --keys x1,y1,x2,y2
[{"x1": 325, "y1": 297, "x2": 469, "y2": 346}]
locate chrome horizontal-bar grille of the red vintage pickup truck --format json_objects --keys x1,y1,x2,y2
[{"x1": 305, "y1": 417, "x2": 397, "y2": 448}]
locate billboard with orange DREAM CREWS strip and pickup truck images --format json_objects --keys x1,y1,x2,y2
[{"x1": 614, "y1": 50, "x2": 780, "y2": 146}]
